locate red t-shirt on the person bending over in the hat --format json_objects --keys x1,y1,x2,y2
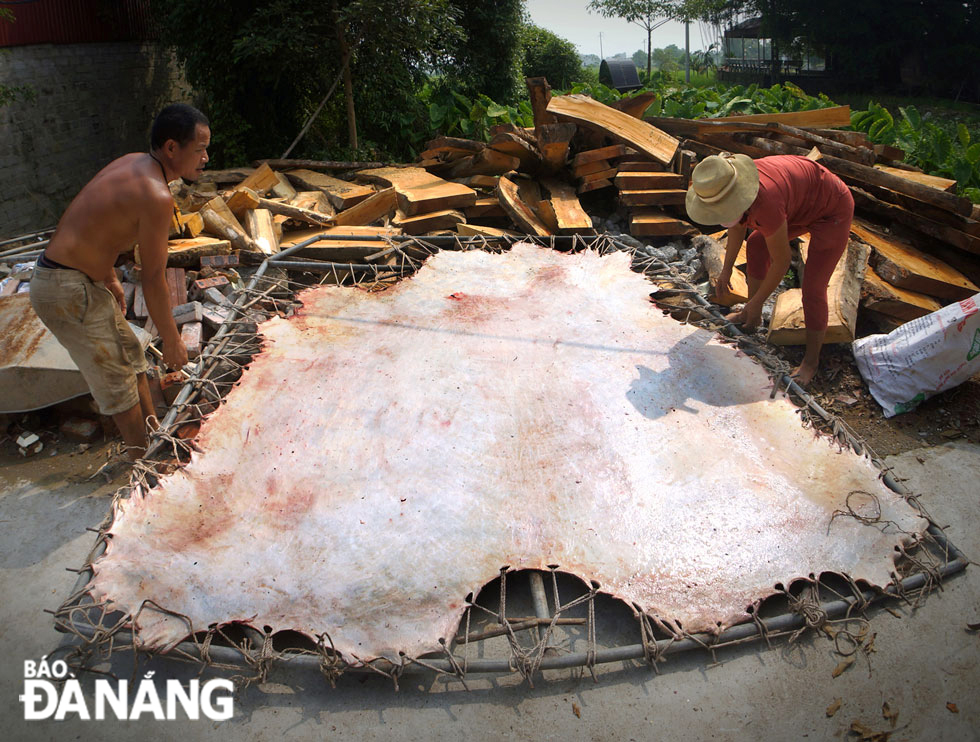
[{"x1": 743, "y1": 155, "x2": 847, "y2": 237}]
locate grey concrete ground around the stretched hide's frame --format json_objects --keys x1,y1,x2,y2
[{"x1": 0, "y1": 443, "x2": 980, "y2": 742}]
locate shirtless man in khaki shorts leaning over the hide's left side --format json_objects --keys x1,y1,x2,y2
[{"x1": 30, "y1": 103, "x2": 211, "y2": 461}]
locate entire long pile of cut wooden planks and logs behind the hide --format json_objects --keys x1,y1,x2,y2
[{"x1": 157, "y1": 78, "x2": 980, "y2": 354}]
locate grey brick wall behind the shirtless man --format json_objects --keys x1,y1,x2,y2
[{"x1": 0, "y1": 42, "x2": 190, "y2": 239}]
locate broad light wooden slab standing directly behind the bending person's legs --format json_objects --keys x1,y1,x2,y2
[{"x1": 768, "y1": 240, "x2": 871, "y2": 345}]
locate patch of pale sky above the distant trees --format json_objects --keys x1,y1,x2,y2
[{"x1": 525, "y1": 0, "x2": 711, "y2": 57}]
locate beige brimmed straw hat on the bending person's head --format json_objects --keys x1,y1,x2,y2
[{"x1": 685, "y1": 152, "x2": 759, "y2": 224}]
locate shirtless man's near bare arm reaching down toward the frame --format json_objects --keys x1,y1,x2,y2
[{"x1": 139, "y1": 193, "x2": 187, "y2": 369}]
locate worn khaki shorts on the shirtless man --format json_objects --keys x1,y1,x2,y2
[{"x1": 31, "y1": 266, "x2": 149, "y2": 415}]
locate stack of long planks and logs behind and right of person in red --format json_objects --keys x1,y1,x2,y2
[{"x1": 646, "y1": 106, "x2": 980, "y2": 334}]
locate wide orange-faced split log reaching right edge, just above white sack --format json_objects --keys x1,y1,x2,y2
[{"x1": 851, "y1": 221, "x2": 980, "y2": 301}]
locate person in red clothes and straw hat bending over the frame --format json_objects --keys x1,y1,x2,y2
[{"x1": 686, "y1": 153, "x2": 854, "y2": 384}]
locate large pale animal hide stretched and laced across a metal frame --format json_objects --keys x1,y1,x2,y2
[{"x1": 90, "y1": 245, "x2": 925, "y2": 661}]
